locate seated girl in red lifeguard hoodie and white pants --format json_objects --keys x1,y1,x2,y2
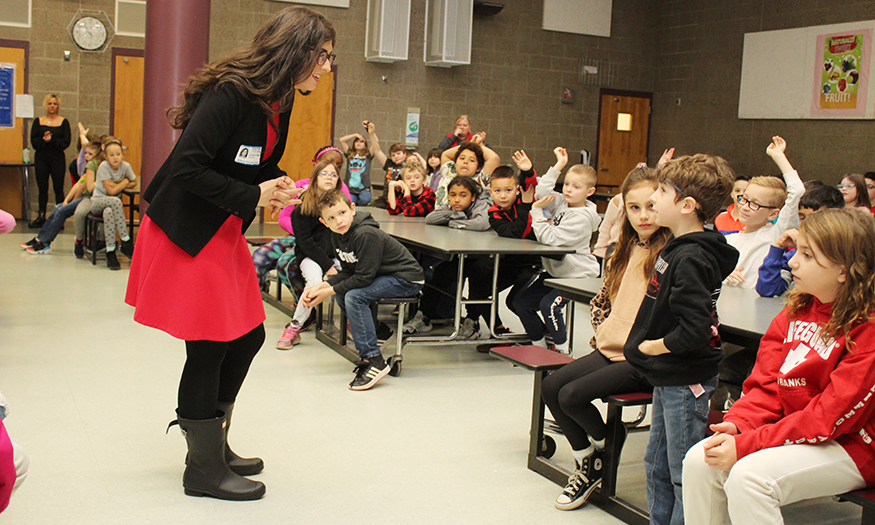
[{"x1": 683, "y1": 209, "x2": 875, "y2": 525}]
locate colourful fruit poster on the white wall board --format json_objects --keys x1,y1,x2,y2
[{"x1": 811, "y1": 29, "x2": 872, "y2": 118}]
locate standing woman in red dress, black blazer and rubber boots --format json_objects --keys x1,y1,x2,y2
[{"x1": 126, "y1": 7, "x2": 335, "y2": 500}]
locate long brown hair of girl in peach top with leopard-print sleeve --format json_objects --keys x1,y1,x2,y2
[{"x1": 605, "y1": 166, "x2": 671, "y2": 298}]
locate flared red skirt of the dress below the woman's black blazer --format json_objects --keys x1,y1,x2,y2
[{"x1": 125, "y1": 215, "x2": 265, "y2": 341}]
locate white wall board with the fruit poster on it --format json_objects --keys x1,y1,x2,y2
[{"x1": 738, "y1": 20, "x2": 875, "y2": 119}]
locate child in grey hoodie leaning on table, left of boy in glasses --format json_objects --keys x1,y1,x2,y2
[{"x1": 404, "y1": 175, "x2": 489, "y2": 339}]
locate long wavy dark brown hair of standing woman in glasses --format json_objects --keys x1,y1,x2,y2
[{"x1": 167, "y1": 7, "x2": 335, "y2": 129}]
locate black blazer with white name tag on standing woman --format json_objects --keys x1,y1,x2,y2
[{"x1": 143, "y1": 82, "x2": 291, "y2": 256}]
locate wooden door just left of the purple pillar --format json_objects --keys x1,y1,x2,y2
[{"x1": 110, "y1": 51, "x2": 145, "y2": 188}]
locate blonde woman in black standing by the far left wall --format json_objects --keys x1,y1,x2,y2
[{"x1": 28, "y1": 93, "x2": 70, "y2": 228}]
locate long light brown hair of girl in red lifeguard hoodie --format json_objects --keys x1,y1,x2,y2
[{"x1": 787, "y1": 208, "x2": 875, "y2": 347}]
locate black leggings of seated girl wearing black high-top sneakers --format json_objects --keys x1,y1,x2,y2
[{"x1": 541, "y1": 350, "x2": 653, "y2": 450}]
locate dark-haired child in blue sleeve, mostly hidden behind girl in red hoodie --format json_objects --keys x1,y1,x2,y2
[{"x1": 756, "y1": 181, "x2": 845, "y2": 297}]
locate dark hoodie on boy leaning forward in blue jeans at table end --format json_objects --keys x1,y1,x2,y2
[{"x1": 328, "y1": 211, "x2": 425, "y2": 295}]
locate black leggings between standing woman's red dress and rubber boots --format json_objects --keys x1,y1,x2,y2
[{"x1": 177, "y1": 324, "x2": 264, "y2": 419}]
